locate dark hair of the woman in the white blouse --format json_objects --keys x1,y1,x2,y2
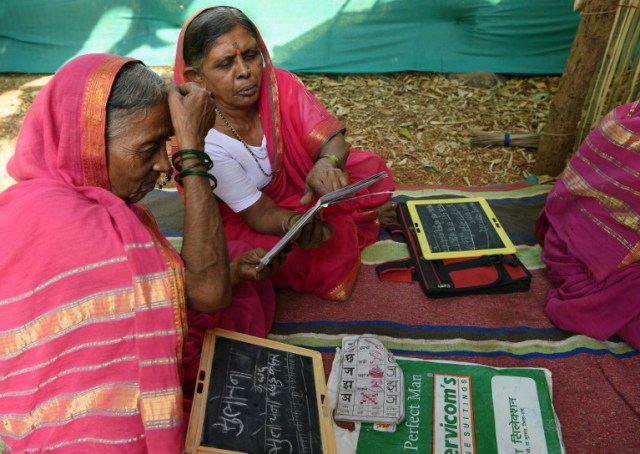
[{"x1": 182, "y1": 6, "x2": 258, "y2": 73}]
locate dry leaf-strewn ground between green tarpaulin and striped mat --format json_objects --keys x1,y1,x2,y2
[{"x1": 0, "y1": 67, "x2": 559, "y2": 190}]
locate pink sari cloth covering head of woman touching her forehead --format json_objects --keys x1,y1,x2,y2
[{"x1": 7, "y1": 54, "x2": 135, "y2": 189}]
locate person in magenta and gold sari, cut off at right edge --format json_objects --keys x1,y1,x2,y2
[{"x1": 536, "y1": 102, "x2": 640, "y2": 350}]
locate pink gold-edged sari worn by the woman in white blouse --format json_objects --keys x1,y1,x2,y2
[{"x1": 174, "y1": 10, "x2": 395, "y2": 301}]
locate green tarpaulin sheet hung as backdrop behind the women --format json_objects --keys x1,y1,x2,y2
[{"x1": 0, "y1": 0, "x2": 579, "y2": 74}]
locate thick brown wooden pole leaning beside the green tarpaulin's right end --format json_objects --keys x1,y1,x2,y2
[{"x1": 533, "y1": 0, "x2": 620, "y2": 176}]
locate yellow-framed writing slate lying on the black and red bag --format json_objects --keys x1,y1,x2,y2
[{"x1": 407, "y1": 197, "x2": 516, "y2": 260}]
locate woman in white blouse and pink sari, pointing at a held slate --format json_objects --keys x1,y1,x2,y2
[{"x1": 174, "y1": 7, "x2": 395, "y2": 301}]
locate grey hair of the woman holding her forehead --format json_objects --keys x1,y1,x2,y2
[{"x1": 105, "y1": 62, "x2": 167, "y2": 143}]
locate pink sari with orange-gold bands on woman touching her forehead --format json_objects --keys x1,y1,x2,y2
[{"x1": 0, "y1": 54, "x2": 274, "y2": 454}]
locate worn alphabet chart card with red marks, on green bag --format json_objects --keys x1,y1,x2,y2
[{"x1": 335, "y1": 334, "x2": 404, "y2": 424}]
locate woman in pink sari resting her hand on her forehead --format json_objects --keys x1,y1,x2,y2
[{"x1": 0, "y1": 54, "x2": 274, "y2": 454}]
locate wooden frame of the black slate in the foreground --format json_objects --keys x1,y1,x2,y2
[{"x1": 185, "y1": 328, "x2": 336, "y2": 454}]
